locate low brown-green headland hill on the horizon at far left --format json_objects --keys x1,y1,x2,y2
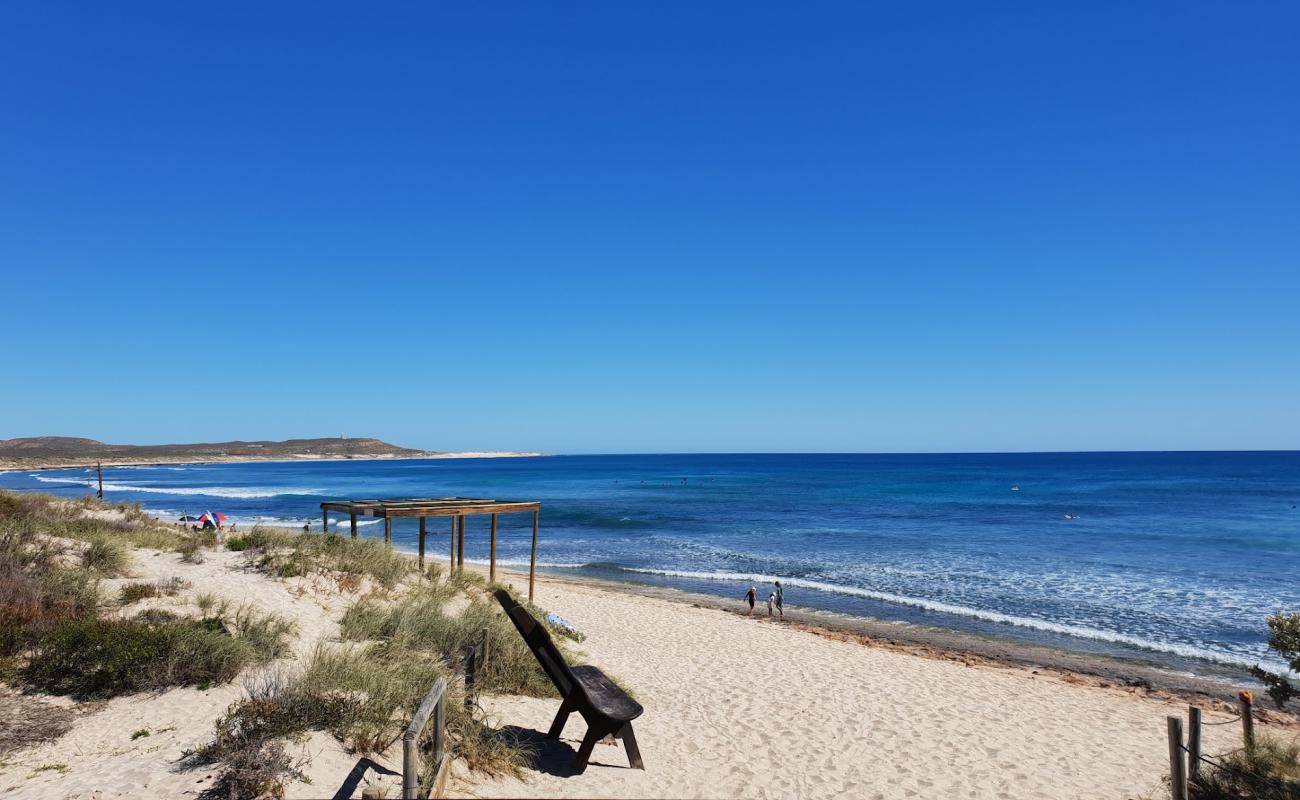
[{"x1": 0, "y1": 436, "x2": 434, "y2": 466}]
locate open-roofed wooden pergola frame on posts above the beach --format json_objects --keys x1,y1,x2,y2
[{"x1": 321, "y1": 497, "x2": 542, "y2": 601}]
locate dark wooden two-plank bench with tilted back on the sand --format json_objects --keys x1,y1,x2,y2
[{"x1": 494, "y1": 589, "x2": 646, "y2": 773}]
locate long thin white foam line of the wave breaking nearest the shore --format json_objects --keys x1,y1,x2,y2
[{"x1": 620, "y1": 567, "x2": 1256, "y2": 666}]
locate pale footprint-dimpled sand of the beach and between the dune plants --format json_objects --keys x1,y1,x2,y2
[{"x1": 0, "y1": 533, "x2": 1284, "y2": 800}]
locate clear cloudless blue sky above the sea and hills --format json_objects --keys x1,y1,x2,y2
[{"x1": 0, "y1": 0, "x2": 1300, "y2": 453}]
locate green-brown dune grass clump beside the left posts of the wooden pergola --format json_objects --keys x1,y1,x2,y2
[{"x1": 237, "y1": 526, "x2": 413, "y2": 589}]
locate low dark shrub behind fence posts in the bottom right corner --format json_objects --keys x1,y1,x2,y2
[{"x1": 1188, "y1": 736, "x2": 1300, "y2": 800}]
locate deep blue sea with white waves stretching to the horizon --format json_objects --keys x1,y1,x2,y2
[{"x1": 0, "y1": 451, "x2": 1300, "y2": 671}]
